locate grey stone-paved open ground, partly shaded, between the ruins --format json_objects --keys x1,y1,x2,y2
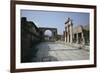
[{"x1": 32, "y1": 42, "x2": 89, "y2": 62}]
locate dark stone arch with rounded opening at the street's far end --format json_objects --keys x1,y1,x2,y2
[{"x1": 39, "y1": 27, "x2": 57, "y2": 41}]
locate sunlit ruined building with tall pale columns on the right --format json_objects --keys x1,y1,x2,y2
[{"x1": 64, "y1": 18, "x2": 90, "y2": 45}]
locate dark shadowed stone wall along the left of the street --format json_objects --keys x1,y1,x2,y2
[{"x1": 21, "y1": 17, "x2": 41, "y2": 62}]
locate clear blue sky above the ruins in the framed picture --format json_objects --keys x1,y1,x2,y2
[{"x1": 21, "y1": 10, "x2": 89, "y2": 34}]
